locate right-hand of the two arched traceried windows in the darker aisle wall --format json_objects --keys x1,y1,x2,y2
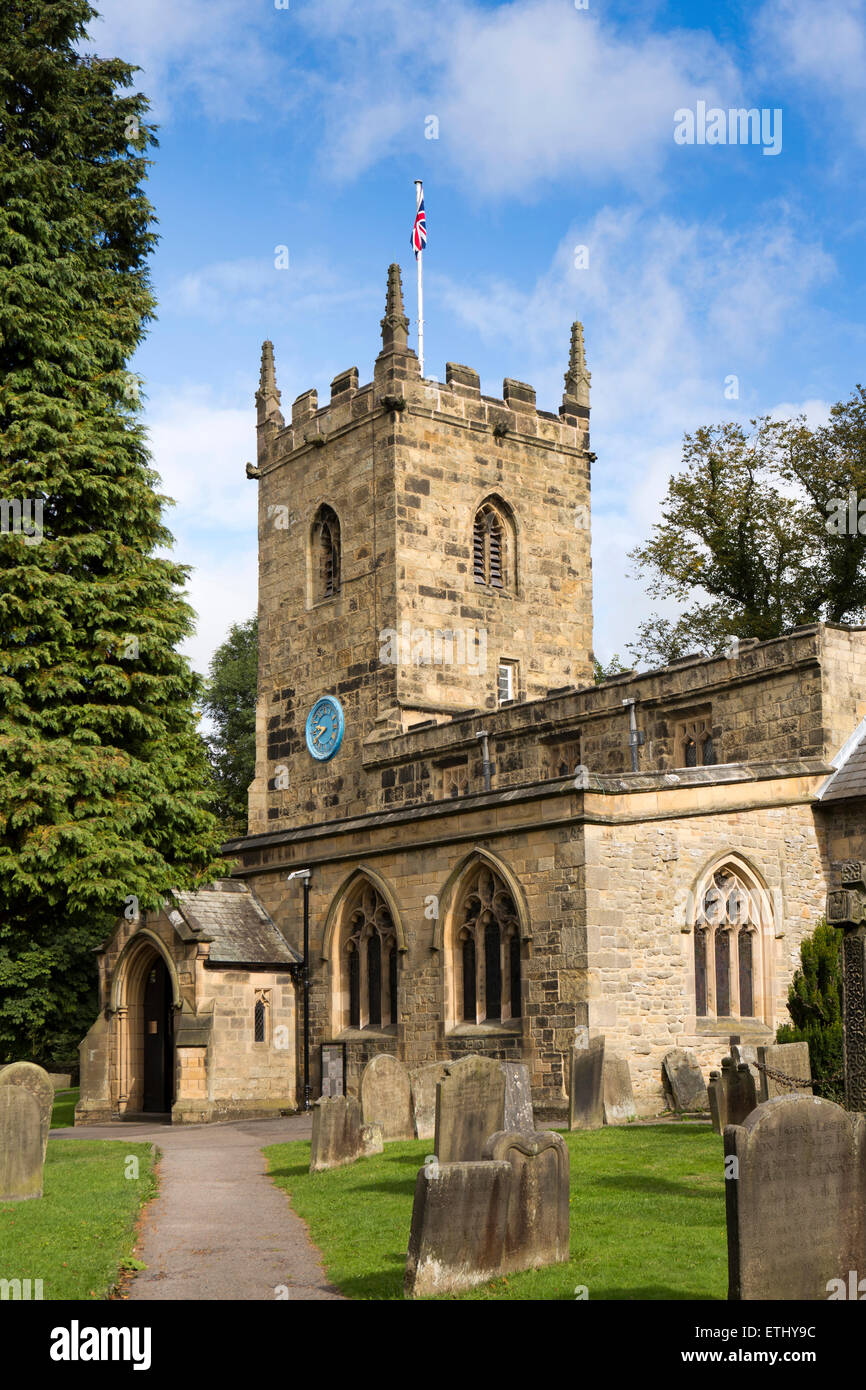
[{"x1": 455, "y1": 865, "x2": 521, "y2": 1023}]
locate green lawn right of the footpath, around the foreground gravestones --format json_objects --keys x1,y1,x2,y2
[{"x1": 264, "y1": 1123, "x2": 727, "y2": 1295}]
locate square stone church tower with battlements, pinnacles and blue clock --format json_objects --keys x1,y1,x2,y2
[{"x1": 247, "y1": 265, "x2": 592, "y2": 834}]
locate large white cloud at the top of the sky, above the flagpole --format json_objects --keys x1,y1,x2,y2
[{"x1": 300, "y1": 0, "x2": 741, "y2": 195}]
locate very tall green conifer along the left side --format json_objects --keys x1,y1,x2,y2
[{"x1": 0, "y1": 0, "x2": 226, "y2": 1062}]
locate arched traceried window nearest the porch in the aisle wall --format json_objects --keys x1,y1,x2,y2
[{"x1": 341, "y1": 883, "x2": 398, "y2": 1029}]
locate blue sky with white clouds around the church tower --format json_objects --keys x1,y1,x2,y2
[{"x1": 88, "y1": 0, "x2": 866, "y2": 670}]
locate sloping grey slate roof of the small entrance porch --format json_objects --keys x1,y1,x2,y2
[{"x1": 174, "y1": 878, "x2": 302, "y2": 967}]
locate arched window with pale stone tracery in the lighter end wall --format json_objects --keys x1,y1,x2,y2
[{"x1": 694, "y1": 863, "x2": 773, "y2": 1024}]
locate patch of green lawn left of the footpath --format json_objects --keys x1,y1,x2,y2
[{"x1": 0, "y1": 1138, "x2": 156, "y2": 1300}]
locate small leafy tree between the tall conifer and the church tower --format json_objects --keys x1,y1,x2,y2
[{"x1": 203, "y1": 617, "x2": 259, "y2": 838}]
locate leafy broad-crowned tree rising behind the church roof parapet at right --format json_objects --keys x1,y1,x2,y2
[{"x1": 628, "y1": 397, "x2": 866, "y2": 663}]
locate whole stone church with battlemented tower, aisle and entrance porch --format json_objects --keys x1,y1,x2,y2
[{"x1": 76, "y1": 265, "x2": 866, "y2": 1123}]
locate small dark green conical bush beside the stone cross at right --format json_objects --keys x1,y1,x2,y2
[{"x1": 776, "y1": 922, "x2": 845, "y2": 1102}]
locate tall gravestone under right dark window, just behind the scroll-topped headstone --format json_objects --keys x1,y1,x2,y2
[{"x1": 434, "y1": 1056, "x2": 505, "y2": 1163}]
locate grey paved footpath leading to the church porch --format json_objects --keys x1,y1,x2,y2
[{"x1": 51, "y1": 1115, "x2": 342, "y2": 1302}]
